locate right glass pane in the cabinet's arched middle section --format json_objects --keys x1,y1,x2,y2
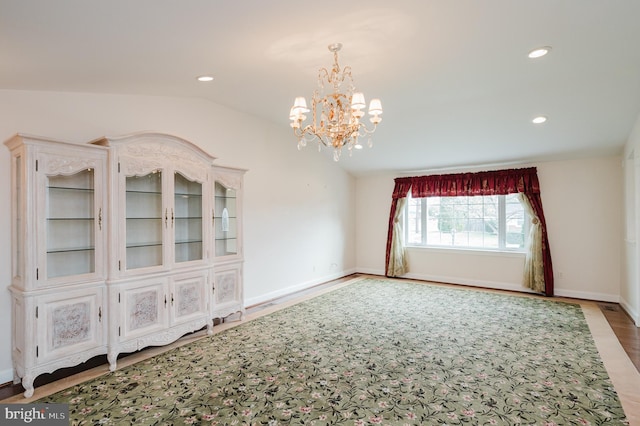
[{"x1": 171, "y1": 173, "x2": 204, "y2": 263}]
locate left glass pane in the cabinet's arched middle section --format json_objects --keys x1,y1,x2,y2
[{"x1": 125, "y1": 171, "x2": 162, "y2": 269}]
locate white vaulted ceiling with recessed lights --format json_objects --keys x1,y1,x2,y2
[{"x1": 0, "y1": 0, "x2": 640, "y2": 174}]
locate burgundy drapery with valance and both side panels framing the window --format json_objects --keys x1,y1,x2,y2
[{"x1": 385, "y1": 167, "x2": 553, "y2": 296}]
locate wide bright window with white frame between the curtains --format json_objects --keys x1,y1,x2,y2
[{"x1": 404, "y1": 194, "x2": 529, "y2": 251}]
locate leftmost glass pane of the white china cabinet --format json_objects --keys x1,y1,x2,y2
[{"x1": 46, "y1": 169, "x2": 96, "y2": 278}]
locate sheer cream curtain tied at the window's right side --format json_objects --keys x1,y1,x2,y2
[{"x1": 518, "y1": 193, "x2": 545, "y2": 292}]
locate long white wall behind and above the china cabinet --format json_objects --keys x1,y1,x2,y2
[{"x1": 0, "y1": 91, "x2": 355, "y2": 383}]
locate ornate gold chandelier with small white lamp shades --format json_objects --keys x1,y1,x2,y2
[{"x1": 289, "y1": 43, "x2": 382, "y2": 161}]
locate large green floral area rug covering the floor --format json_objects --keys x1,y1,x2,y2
[{"x1": 38, "y1": 279, "x2": 627, "y2": 426}]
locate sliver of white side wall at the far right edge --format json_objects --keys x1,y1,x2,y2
[{"x1": 620, "y1": 111, "x2": 640, "y2": 327}]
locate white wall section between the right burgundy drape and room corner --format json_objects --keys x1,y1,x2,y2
[{"x1": 538, "y1": 157, "x2": 623, "y2": 302}]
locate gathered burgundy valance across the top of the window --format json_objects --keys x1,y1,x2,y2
[{"x1": 393, "y1": 167, "x2": 540, "y2": 199}]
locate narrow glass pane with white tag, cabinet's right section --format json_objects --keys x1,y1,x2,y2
[{"x1": 214, "y1": 182, "x2": 238, "y2": 256}]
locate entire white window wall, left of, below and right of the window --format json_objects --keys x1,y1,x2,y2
[{"x1": 356, "y1": 157, "x2": 623, "y2": 302}]
